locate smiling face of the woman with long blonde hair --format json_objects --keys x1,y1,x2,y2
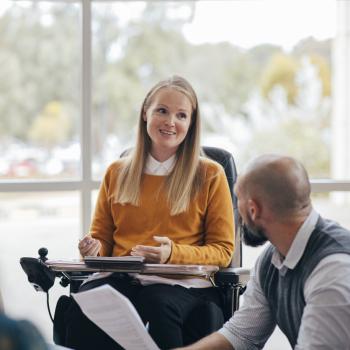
[{"x1": 143, "y1": 87, "x2": 192, "y2": 162}]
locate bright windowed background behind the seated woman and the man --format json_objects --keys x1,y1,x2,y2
[{"x1": 0, "y1": 0, "x2": 350, "y2": 349}]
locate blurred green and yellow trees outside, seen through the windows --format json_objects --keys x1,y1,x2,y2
[{"x1": 0, "y1": 1, "x2": 331, "y2": 176}]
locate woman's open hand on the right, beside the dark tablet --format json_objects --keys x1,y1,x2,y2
[{"x1": 131, "y1": 236, "x2": 171, "y2": 264}]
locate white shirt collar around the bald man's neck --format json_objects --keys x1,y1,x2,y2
[{"x1": 271, "y1": 210, "x2": 319, "y2": 275}]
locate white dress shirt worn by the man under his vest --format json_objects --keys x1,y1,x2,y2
[{"x1": 219, "y1": 211, "x2": 350, "y2": 350}]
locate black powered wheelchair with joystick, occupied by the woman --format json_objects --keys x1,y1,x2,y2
[{"x1": 20, "y1": 147, "x2": 250, "y2": 345}]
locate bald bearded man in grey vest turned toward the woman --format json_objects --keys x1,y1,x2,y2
[{"x1": 175, "y1": 155, "x2": 350, "y2": 350}]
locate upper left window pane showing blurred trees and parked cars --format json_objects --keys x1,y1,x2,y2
[{"x1": 0, "y1": 1, "x2": 81, "y2": 180}]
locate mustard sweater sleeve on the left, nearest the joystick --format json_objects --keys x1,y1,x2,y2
[{"x1": 90, "y1": 166, "x2": 116, "y2": 256}]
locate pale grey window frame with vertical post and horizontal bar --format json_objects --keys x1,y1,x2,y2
[{"x1": 0, "y1": 0, "x2": 350, "y2": 236}]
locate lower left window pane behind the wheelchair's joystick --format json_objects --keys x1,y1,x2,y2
[{"x1": 0, "y1": 191, "x2": 80, "y2": 330}]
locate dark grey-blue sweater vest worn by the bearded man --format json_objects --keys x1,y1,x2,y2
[{"x1": 259, "y1": 217, "x2": 350, "y2": 348}]
